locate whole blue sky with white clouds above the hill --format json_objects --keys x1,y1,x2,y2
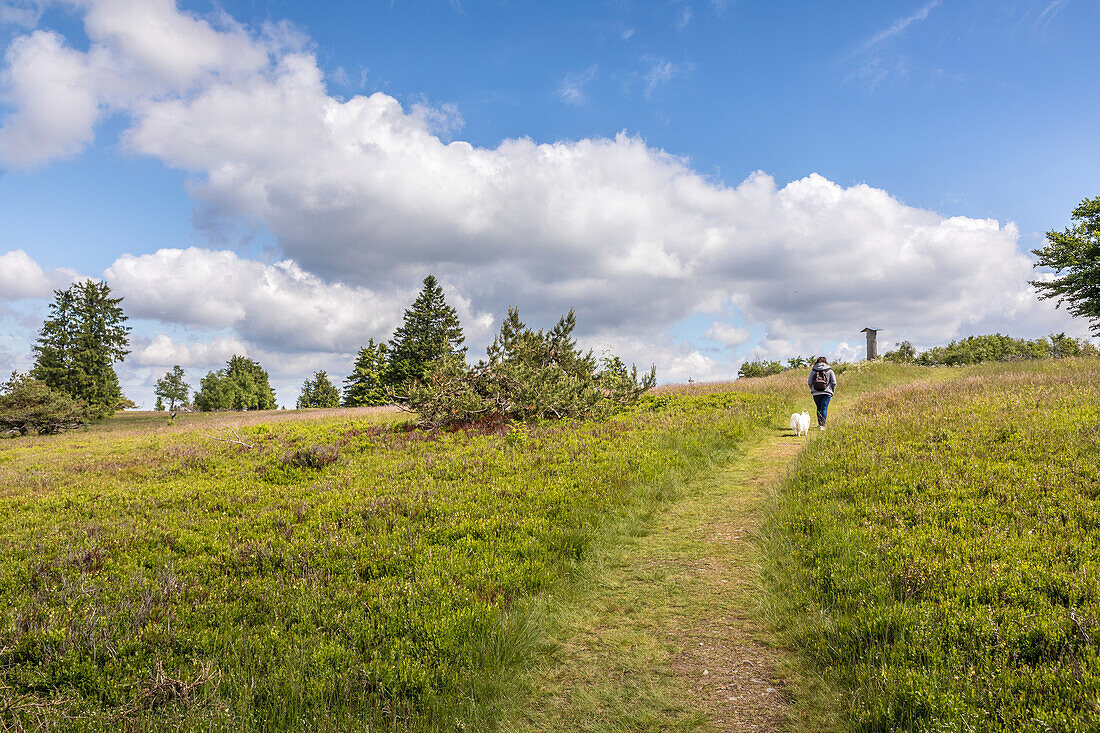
[{"x1": 0, "y1": 0, "x2": 1100, "y2": 408}]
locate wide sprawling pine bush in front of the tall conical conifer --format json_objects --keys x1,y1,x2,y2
[{"x1": 408, "y1": 308, "x2": 657, "y2": 427}]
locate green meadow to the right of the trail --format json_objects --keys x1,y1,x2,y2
[{"x1": 766, "y1": 360, "x2": 1100, "y2": 731}]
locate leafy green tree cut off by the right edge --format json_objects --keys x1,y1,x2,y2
[{"x1": 1031, "y1": 196, "x2": 1100, "y2": 335}]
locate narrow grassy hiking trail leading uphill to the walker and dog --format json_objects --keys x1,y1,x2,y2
[{"x1": 502, "y1": 428, "x2": 818, "y2": 732}]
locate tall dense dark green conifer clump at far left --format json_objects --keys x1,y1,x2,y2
[{"x1": 31, "y1": 280, "x2": 130, "y2": 418}]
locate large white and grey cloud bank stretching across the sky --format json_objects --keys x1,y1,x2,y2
[{"x1": 0, "y1": 0, "x2": 1082, "y2": 387}]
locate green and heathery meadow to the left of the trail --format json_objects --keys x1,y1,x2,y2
[{"x1": 0, "y1": 392, "x2": 784, "y2": 731}]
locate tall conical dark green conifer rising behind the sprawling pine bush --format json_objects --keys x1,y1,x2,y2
[{"x1": 385, "y1": 275, "x2": 466, "y2": 390}]
